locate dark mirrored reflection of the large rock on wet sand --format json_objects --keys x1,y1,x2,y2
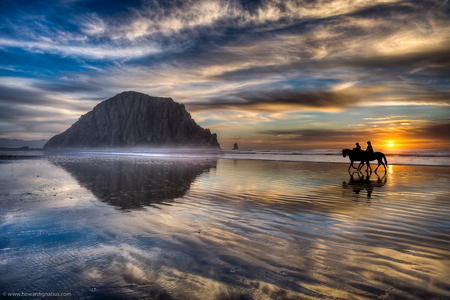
[{"x1": 53, "y1": 157, "x2": 217, "y2": 209}]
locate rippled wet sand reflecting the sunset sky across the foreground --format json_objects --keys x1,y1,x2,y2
[{"x1": 0, "y1": 155, "x2": 450, "y2": 299}]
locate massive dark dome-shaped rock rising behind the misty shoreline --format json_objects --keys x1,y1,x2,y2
[{"x1": 44, "y1": 92, "x2": 220, "y2": 149}]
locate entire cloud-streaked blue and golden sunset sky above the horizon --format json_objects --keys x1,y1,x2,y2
[{"x1": 0, "y1": 0, "x2": 450, "y2": 151}]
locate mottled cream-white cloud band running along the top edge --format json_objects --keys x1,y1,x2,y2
[{"x1": 68, "y1": 0, "x2": 406, "y2": 41}]
